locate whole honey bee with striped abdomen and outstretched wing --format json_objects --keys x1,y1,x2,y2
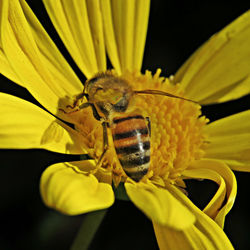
[{"x1": 65, "y1": 72, "x2": 193, "y2": 182}]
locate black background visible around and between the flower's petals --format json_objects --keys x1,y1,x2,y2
[{"x1": 0, "y1": 0, "x2": 250, "y2": 250}]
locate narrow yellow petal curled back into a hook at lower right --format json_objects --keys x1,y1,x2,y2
[{"x1": 183, "y1": 159, "x2": 237, "y2": 228}]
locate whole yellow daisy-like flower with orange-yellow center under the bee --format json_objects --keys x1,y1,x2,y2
[{"x1": 0, "y1": 0, "x2": 250, "y2": 249}]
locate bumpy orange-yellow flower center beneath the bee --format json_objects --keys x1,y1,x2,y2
[{"x1": 67, "y1": 70, "x2": 208, "y2": 185}]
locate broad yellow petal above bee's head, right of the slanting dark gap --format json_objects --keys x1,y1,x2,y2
[{"x1": 43, "y1": 0, "x2": 106, "y2": 78}]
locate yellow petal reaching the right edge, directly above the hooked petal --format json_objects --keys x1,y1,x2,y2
[{"x1": 205, "y1": 110, "x2": 250, "y2": 172}]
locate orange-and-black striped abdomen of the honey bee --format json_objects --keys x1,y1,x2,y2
[{"x1": 111, "y1": 115, "x2": 150, "y2": 181}]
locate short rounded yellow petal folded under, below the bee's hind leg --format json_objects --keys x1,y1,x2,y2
[{"x1": 40, "y1": 161, "x2": 114, "y2": 215}]
